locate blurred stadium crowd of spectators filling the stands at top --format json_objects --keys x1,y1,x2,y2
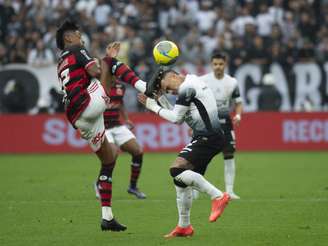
[{"x1": 0, "y1": 0, "x2": 328, "y2": 112}]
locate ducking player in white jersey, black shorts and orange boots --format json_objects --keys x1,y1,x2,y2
[{"x1": 139, "y1": 70, "x2": 230, "y2": 237}]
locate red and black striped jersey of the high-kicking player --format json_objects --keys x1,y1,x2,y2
[{"x1": 57, "y1": 46, "x2": 95, "y2": 126}]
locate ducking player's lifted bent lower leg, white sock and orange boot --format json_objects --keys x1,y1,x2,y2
[{"x1": 170, "y1": 167, "x2": 230, "y2": 222}]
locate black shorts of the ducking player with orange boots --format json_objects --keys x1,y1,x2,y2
[{"x1": 178, "y1": 133, "x2": 224, "y2": 175}]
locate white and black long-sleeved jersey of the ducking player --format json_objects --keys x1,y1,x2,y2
[{"x1": 159, "y1": 75, "x2": 221, "y2": 136}]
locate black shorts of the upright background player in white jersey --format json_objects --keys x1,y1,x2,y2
[{"x1": 219, "y1": 115, "x2": 236, "y2": 153}]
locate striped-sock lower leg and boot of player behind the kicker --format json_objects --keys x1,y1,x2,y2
[{"x1": 128, "y1": 154, "x2": 146, "y2": 199}]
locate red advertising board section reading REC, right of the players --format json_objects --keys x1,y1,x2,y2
[{"x1": 236, "y1": 112, "x2": 328, "y2": 150}]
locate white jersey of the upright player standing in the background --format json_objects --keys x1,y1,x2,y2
[{"x1": 201, "y1": 72, "x2": 242, "y2": 115}]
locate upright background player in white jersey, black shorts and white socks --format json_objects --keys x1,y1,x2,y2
[{"x1": 201, "y1": 52, "x2": 243, "y2": 199}]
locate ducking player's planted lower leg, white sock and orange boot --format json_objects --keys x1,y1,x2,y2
[{"x1": 164, "y1": 186, "x2": 194, "y2": 238}]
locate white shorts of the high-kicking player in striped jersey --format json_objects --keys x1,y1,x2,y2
[{"x1": 75, "y1": 79, "x2": 106, "y2": 152}]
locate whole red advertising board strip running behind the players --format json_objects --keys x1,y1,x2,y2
[{"x1": 0, "y1": 113, "x2": 328, "y2": 153}]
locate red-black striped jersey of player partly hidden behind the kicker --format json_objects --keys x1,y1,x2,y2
[{"x1": 104, "y1": 82, "x2": 125, "y2": 129}]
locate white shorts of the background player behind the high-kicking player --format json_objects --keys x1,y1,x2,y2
[{"x1": 106, "y1": 125, "x2": 136, "y2": 146}]
